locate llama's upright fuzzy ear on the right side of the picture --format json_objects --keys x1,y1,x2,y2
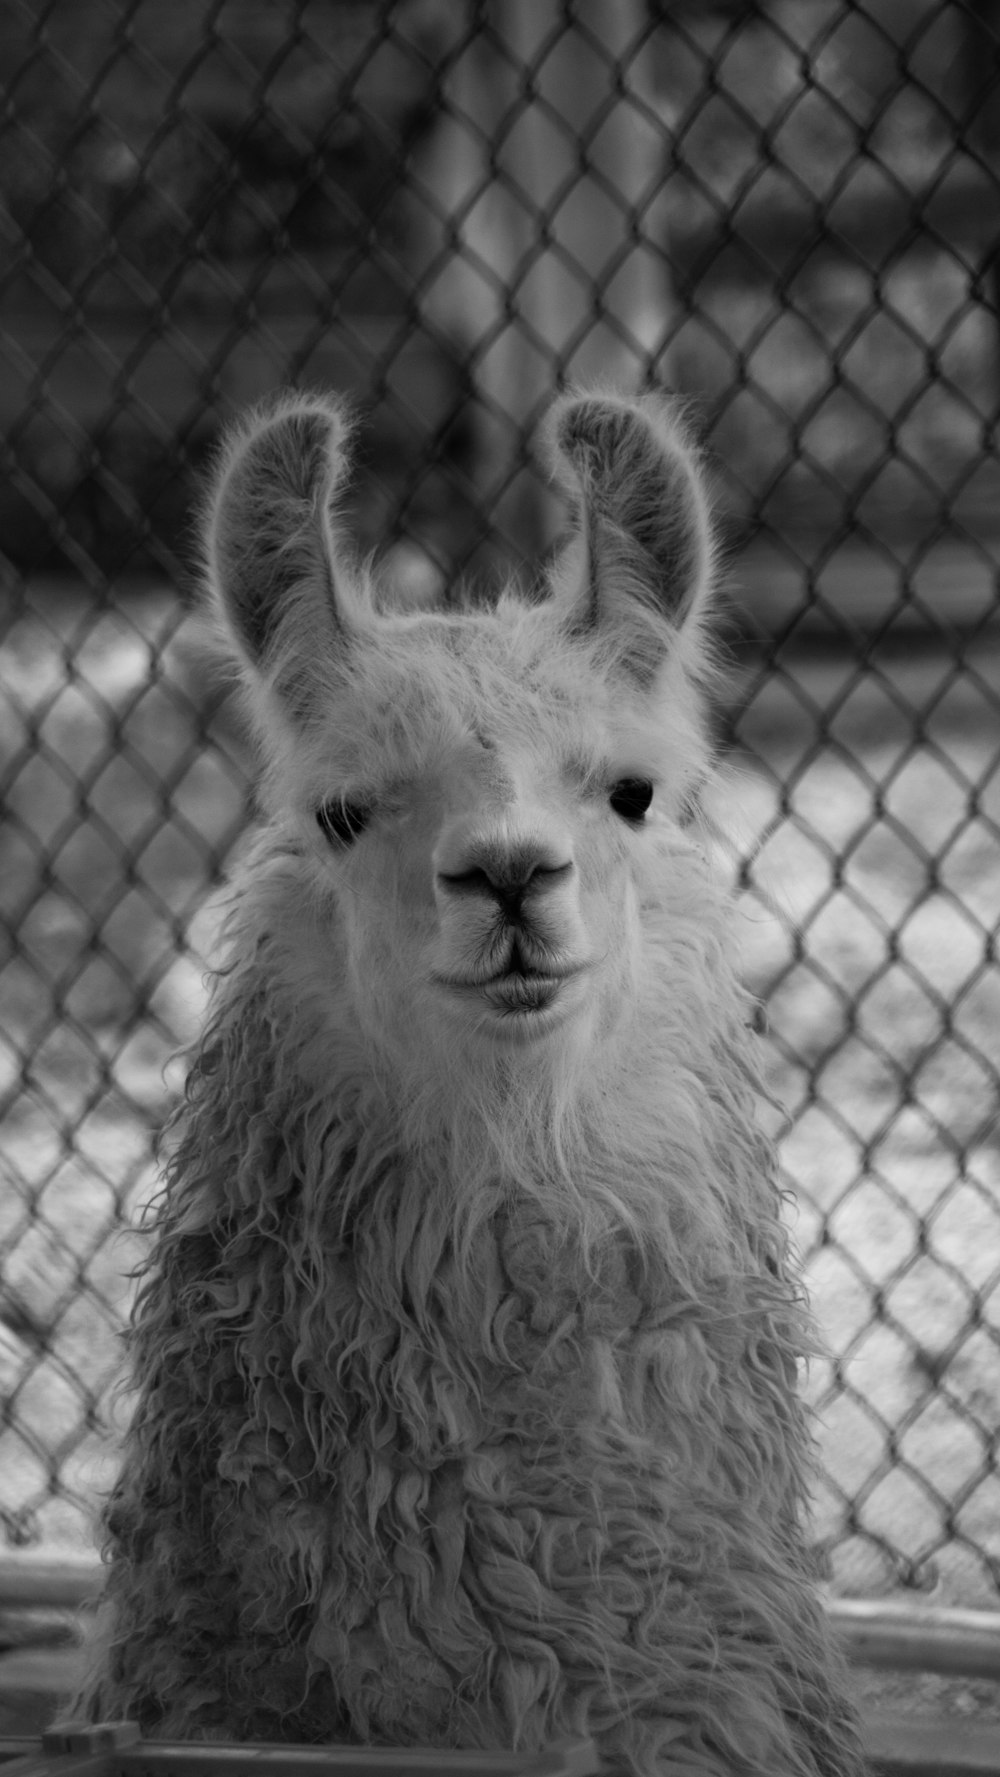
[{"x1": 551, "y1": 394, "x2": 712, "y2": 682}]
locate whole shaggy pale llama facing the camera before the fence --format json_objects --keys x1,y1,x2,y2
[{"x1": 80, "y1": 393, "x2": 860, "y2": 1777}]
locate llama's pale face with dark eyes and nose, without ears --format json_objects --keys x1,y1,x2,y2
[{"x1": 300, "y1": 613, "x2": 659, "y2": 1047}]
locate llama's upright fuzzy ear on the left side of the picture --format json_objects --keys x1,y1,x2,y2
[{"x1": 206, "y1": 394, "x2": 353, "y2": 691}]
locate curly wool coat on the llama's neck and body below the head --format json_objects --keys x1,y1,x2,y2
[{"x1": 74, "y1": 392, "x2": 860, "y2": 1777}]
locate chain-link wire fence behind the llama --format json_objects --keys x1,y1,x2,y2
[{"x1": 0, "y1": 0, "x2": 1000, "y2": 1606}]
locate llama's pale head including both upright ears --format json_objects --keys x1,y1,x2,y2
[{"x1": 206, "y1": 394, "x2": 710, "y2": 1137}]
